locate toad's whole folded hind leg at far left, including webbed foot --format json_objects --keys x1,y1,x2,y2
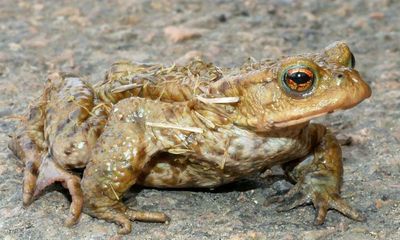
[{"x1": 9, "y1": 73, "x2": 97, "y2": 226}]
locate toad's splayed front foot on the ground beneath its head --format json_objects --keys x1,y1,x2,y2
[{"x1": 275, "y1": 174, "x2": 366, "y2": 225}]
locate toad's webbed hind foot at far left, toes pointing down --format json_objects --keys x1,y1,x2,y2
[{"x1": 34, "y1": 156, "x2": 83, "y2": 226}]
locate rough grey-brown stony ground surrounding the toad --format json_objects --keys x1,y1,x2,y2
[{"x1": 0, "y1": 0, "x2": 400, "y2": 239}]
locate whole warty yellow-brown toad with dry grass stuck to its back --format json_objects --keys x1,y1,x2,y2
[{"x1": 10, "y1": 42, "x2": 371, "y2": 233}]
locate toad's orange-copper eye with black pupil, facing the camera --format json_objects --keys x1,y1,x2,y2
[{"x1": 283, "y1": 67, "x2": 315, "y2": 94}]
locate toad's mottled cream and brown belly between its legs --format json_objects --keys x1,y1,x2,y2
[{"x1": 137, "y1": 124, "x2": 312, "y2": 188}]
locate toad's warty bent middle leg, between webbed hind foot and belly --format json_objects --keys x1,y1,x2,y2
[{"x1": 82, "y1": 99, "x2": 168, "y2": 234}]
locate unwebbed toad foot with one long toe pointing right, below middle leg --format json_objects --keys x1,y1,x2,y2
[{"x1": 88, "y1": 202, "x2": 169, "y2": 234}]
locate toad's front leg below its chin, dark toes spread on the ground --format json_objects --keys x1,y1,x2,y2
[{"x1": 279, "y1": 124, "x2": 365, "y2": 225}]
